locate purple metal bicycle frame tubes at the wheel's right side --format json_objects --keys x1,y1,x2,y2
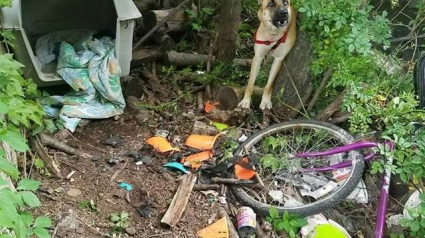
[{"x1": 293, "y1": 141, "x2": 394, "y2": 238}]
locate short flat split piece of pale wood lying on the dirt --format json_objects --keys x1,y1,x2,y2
[{"x1": 161, "y1": 174, "x2": 197, "y2": 227}]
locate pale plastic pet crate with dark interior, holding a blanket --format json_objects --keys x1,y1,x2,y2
[{"x1": 1, "y1": 0, "x2": 141, "y2": 86}]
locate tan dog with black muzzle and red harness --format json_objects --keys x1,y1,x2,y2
[{"x1": 239, "y1": 0, "x2": 297, "y2": 110}]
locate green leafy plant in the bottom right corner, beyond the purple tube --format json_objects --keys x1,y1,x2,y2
[{"x1": 400, "y1": 193, "x2": 425, "y2": 237}]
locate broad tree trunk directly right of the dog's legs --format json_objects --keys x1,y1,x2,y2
[{"x1": 273, "y1": 30, "x2": 313, "y2": 119}]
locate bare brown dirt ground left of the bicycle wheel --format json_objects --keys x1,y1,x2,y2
[{"x1": 37, "y1": 110, "x2": 219, "y2": 238}]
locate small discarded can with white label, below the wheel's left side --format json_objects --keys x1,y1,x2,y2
[{"x1": 236, "y1": 207, "x2": 257, "y2": 237}]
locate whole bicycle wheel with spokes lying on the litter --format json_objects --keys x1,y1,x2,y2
[{"x1": 231, "y1": 121, "x2": 364, "y2": 216}]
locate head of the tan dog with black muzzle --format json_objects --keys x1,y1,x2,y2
[{"x1": 258, "y1": 0, "x2": 293, "y2": 28}]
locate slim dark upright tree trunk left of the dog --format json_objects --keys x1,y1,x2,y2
[{"x1": 217, "y1": 0, "x2": 241, "y2": 63}]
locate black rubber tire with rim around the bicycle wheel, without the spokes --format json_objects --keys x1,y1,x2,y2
[{"x1": 231, "y1": 120, "x2": 364, "y2": 217}]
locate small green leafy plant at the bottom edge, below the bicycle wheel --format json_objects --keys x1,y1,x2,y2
[{"x1": 267, "y1": 207, "x2": 307, "y2": 237}]
